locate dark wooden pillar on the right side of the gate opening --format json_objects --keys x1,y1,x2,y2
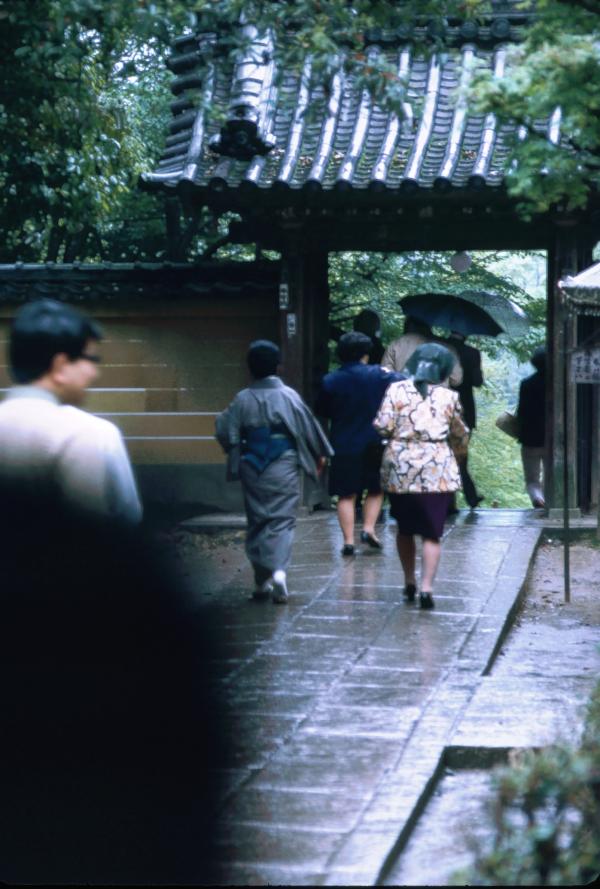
[{"x1": 546, "y1": 225, "x2": 591, "y2": 509}]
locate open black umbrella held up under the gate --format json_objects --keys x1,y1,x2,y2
[{"x1": 400, "y1": 293, "x2": 503, "y2": 336}]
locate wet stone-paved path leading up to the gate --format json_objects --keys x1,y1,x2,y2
[{"x1": 178, "y1": 510, "x2": 592, "y2": 885}]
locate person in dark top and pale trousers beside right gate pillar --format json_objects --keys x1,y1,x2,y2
[{"x1": 517, "y1": 346, "x2": 546, "y2": 509}]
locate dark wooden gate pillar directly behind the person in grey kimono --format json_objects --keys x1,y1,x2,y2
[{"x1": 279, "y1": 223, "x2": 329, "y2": 508}]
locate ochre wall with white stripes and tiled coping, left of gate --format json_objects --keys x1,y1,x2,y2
[{"x1": 0, "y1": 262, "x2": 280, "y2": 510}]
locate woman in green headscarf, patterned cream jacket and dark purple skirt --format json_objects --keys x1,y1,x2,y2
[{"x1": 374, "y1": 343, "x2": 469, "y2": 608}]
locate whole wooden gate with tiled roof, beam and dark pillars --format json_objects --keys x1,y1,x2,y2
[{"x1": 143, "y1": 2, "x2": 600, "y2": 508}]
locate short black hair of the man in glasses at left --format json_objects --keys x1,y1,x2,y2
[{"x1": 9, "y1": 299, "x2": 102, "y2": 383}]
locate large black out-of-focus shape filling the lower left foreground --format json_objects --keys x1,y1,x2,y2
[{"x1": 0, "y1": 481, "x2": 225, "y2": 884}]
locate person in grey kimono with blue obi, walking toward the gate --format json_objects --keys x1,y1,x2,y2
[{"x1": 216, "y1": 340, "x2": 333, "y2": 604}]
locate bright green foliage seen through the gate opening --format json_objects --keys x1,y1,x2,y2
[{"x1": 329, "y1": 252, "x2": 546, "y2": 509}]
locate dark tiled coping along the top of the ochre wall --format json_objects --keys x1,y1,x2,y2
[{"x1": 0, "y1": 261, "x2": 280, "y2": 304}]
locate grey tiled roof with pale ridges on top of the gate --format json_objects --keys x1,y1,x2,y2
[{"x1": 142, "y1": 4, "x2": 560, "y2": 206}]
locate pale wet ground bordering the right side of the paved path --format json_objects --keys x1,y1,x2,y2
[{"x1": 384, "y1": 544, "x2": 600, "y2": 886}]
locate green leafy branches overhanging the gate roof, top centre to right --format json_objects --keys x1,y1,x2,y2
[{"x1": 186, "y1": 0, "x2": 600, "y2": 216}]
